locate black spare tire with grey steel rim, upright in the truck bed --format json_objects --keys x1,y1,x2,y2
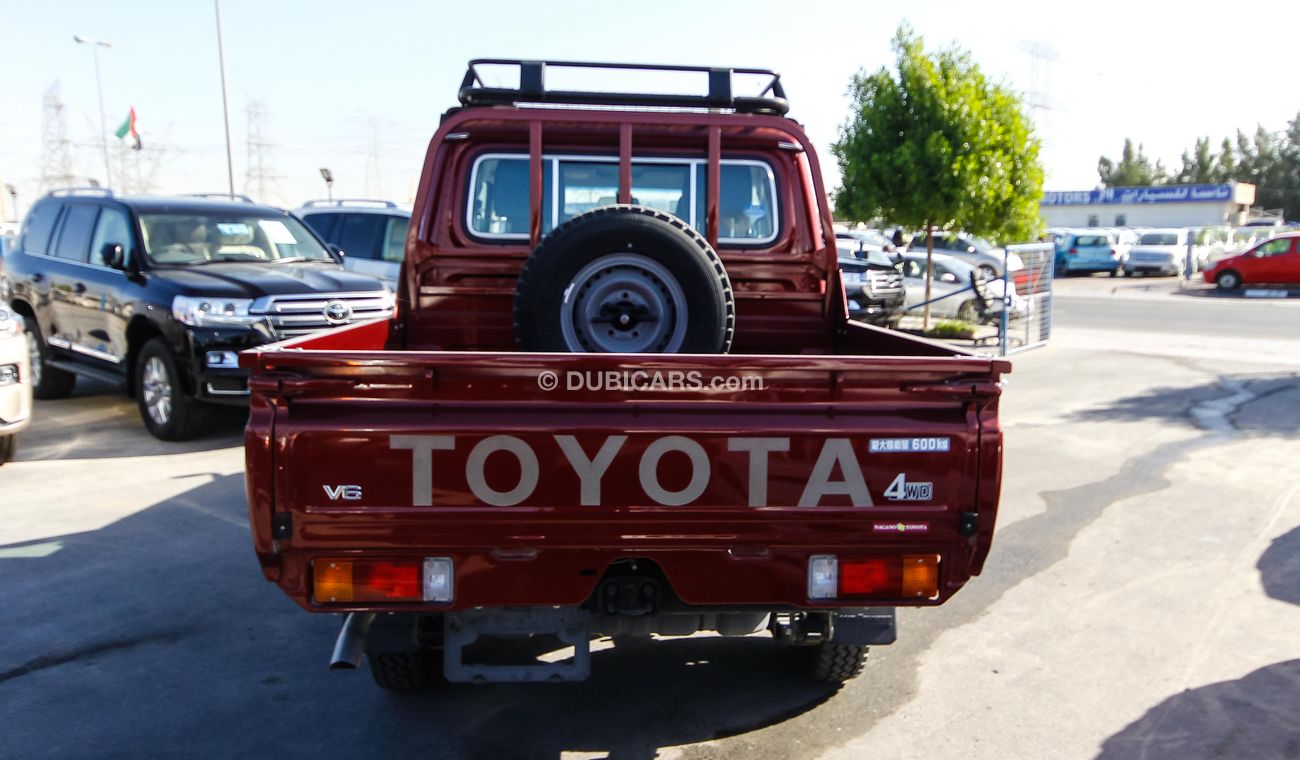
[{"x1": 515, "y1": 205, "x2": 736, "y2": 353}]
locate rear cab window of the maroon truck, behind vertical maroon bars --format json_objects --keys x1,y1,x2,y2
[{"x1": 465, "y1": 153, "x2": 780, "y2": 244}]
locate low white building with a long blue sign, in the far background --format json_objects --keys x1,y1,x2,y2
[{"x1": 1039, "y1": 182, "x2": 1255, "y2": 227}]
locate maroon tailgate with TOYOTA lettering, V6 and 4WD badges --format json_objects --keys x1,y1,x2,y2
[{"x1": 246, "y1": 340, "x2": 1009, "y2": 609}]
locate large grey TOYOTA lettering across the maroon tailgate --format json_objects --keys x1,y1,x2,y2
[{"x1": 368, "y1": 435, "x2": 946, "y2": 507}]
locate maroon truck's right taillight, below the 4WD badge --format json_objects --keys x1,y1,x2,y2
[{"x1": 809, "y1": 555, "x2": 939, "y2": 599}]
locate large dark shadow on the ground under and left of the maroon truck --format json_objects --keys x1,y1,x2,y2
[{"x1": 0, "y1": 475, "x2": 835, "y2": 759}]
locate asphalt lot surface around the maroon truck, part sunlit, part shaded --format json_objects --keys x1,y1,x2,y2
[{"x1": 0, "y1": 278, "x2": 1300, "y2": 760}]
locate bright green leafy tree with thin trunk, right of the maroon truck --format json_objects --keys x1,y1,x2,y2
[{"x1": 832, "y1": 25, "x2": 1043, "y2": 330}]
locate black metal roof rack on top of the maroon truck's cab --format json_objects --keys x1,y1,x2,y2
[{"x1": 460, "y1": 58, "x2": 790, "y2": 116}]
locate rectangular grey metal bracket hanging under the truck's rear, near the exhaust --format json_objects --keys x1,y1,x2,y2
[{"x1": 442, "y1": 607, "x2": 592, "y2": 683}]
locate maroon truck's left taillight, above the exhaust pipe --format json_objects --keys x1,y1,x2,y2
[{"x1": 312, "y1": 557, "x2": 452, "y2": 603}]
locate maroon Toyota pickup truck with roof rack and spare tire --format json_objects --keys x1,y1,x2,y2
[{"x1": 241, "y1": 60, "x2": 1010, "y2": 691}]
